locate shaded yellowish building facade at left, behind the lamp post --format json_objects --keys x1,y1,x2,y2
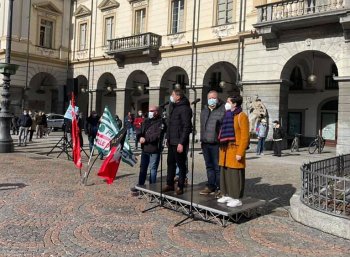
[{"x1": 0, "y1": 0, "x2": 71, "y2": 114}]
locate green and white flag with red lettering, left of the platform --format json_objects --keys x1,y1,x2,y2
[{"x1": 95, "y1": 107, "x2": 119, "y2": 155}]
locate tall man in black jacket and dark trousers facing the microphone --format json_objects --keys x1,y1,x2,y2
[{"x1": 163, "y1": 89, "x2": 192, "y2": 195}]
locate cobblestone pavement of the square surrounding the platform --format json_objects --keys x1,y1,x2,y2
[{"x1": 0, "y1": 132, "x2": 350, "y2": 257}]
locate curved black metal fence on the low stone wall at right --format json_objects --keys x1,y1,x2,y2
[{"x1": 300, "y1": 154, "x2": 350, "y2": 219}]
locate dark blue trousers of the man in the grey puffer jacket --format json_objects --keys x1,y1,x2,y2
[{"x1": 202, "y1": 143, "x2": 220, "y2": 191}]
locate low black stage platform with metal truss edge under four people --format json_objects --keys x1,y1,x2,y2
[{"x1": 135, "y1": 182, "x2": 265, "y2": 226}]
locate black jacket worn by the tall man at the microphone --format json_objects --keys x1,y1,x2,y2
[{"x1": 166, "y1": 97, "x2": 192, "y2": 145}]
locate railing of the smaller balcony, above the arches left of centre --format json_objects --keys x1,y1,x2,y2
[{"x1": 106, "y1": 32, "x2": 162, "y2": 54}]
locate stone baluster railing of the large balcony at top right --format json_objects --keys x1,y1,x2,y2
[{"x1": 257, "y1": 0, "x2": 350, "y2": 23}]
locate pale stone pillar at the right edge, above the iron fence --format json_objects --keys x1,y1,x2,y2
[{"x1": 337, "y1": 80, "x2": 350, "y2": 154}]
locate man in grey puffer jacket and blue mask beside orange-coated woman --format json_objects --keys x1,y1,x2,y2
[{"x1": 199, "y1": 90, "x2": 225, "y2": 195}]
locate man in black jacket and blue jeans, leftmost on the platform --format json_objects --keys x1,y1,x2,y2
[{"x1": 131, "y1": 106, "x2": 166, "y2": 192}]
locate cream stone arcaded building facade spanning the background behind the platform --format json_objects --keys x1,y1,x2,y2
[{"x1": 0, "y1": 0, "x2": 350, "y2": 153}]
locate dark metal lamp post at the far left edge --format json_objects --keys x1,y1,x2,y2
[{"x1": 0, "y1": 0, "x2": 18, "y2": 153}]
